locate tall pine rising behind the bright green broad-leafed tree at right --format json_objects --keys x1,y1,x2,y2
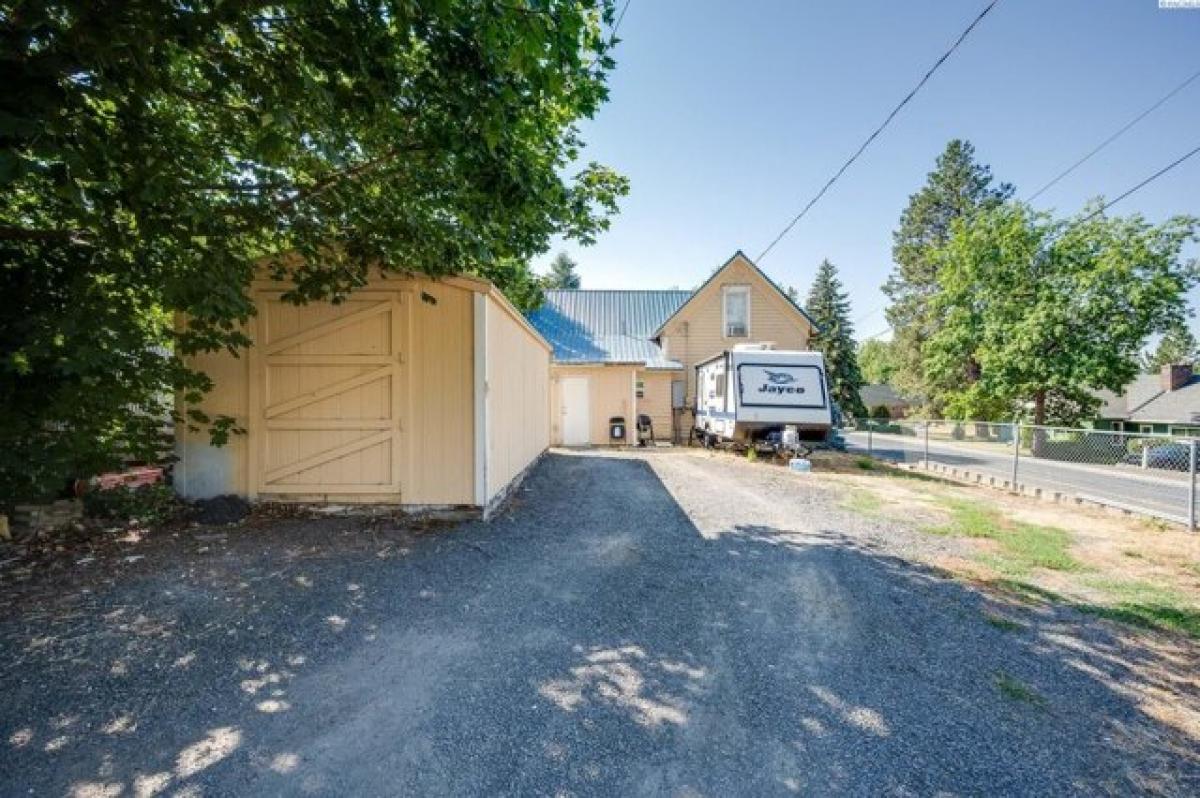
[{"x1": 883, "y1": 139, "x2": 1013, "y2": 413}]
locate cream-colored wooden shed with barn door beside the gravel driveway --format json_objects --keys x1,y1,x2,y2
[{"x1": 175, "y1": 272, "x2": 550, "y2": 510}]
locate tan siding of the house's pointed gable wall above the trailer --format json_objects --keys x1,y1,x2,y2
[{"x1": 661, "y1": 257, "x2": 811, "y2": 407}]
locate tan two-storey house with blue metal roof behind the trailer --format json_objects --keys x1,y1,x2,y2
[{"x1": 529, "y1": 251, "x2": 814, "y2": 445}]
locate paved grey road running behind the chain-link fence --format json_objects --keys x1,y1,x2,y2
[{"x1": 845, "y1": 432, "x2": 1188, "y2": 520}]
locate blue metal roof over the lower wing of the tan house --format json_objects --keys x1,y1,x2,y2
[{"x1": 529, "y1": 290, "x2": 692, "y2": 368}]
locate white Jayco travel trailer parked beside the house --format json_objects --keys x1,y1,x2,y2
[{"x1": 695, "y1": 343, "x2": 833, "y2": 449}]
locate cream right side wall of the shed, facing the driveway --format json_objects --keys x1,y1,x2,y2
[{"x1": 482, "y1": 289, "x2": 550, "y2": 500}]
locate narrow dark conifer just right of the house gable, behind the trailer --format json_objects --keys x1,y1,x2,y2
[{"x1": 805, "y1": 259, "x2": 866, "y2": 418}]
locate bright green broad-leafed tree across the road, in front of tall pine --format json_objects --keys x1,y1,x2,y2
[{"x1": 925, "y1": 203, "x2": 1198, "y2": 424}]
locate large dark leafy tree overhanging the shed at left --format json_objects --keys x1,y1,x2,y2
[{"x1": 0, "y1": 0, "x2": 628, "y2": 504}]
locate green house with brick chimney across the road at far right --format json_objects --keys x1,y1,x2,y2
[{"x1": 1096, "y1": 364, "x2": 1200, "y2": 438}]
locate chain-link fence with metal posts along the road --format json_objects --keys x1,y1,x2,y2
[{"x1": 846, "y1": 420, "x2": 1200, "y2": 529}]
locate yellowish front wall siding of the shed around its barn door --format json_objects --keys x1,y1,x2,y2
[{"x1": 176, "y1": 278, "x2": 475, "y2": 505}]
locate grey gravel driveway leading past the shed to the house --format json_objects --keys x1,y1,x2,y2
[{"x1": 0, "y1": 452, "x2": 1200, "y2": 796}]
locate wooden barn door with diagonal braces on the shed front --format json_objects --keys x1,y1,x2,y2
[{"x1": 251, "y1": 292, "x2": 408, "y2": 494}]
